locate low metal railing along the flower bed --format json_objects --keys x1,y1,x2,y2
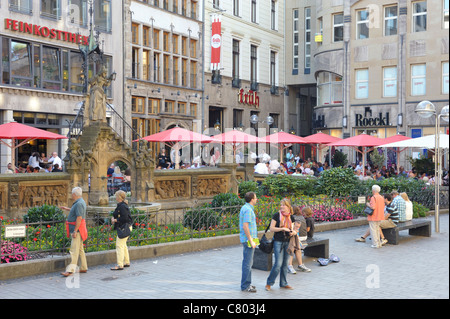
[{"x1": 0, "y1": 190, "x2": 448, "y2": 263}]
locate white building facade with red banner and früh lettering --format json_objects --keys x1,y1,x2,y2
[{"x1": 202, "y1": 0, "x2": 288, "y2": 148}]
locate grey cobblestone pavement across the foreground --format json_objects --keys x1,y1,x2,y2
[{"x1": 0, "y1": 214, "x2": 449, "y2": 302}]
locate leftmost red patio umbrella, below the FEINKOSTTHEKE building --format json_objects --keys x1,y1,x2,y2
[{"x1": 0, "y1": 122, "x2": 67, "y2": 172}]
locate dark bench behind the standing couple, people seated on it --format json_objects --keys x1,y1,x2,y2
[{"x1": 252, "y1": 237, "x2": 330, "y2": 271}]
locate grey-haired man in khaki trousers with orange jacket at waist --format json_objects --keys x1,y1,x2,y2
[{"x1": 60, "y1": 187, "x2": 88, "y2": 277}]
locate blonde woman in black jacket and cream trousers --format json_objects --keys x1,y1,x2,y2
[{"x1": 111, "y1": 190, "x2": 133, "y2": 270}]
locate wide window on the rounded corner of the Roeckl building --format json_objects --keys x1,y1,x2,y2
[{"x1": 317, "y1": 72, "x2": 343, "y2": 105}]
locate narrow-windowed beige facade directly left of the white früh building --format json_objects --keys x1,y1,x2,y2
[{"x1": 124, "y1": 0, "x2": 203, "y2": 156}]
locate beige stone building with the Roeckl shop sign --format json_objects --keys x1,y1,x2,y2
[{"x1": 286, "y1": 0, "x2": 449, "y2": 165}]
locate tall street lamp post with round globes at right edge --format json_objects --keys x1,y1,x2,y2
[{"x1": 415, "y1": 101, "x2": 449, "y2": 233}]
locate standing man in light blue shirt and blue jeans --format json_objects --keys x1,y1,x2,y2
[{"x1": 239, "y1": 192, "x2": 258, "y2": 292}]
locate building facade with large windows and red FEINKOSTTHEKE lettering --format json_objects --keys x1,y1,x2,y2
[{"x1": 0, "y1": 0, "x2": 123, "y2": 173}]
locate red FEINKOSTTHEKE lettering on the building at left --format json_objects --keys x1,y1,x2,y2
[{"x1": 5, "y1": 18, "x2": 89, "y2": 45}]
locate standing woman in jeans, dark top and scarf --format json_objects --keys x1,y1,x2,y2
[{"x1": 265, "y1": 198, "x2": 297, "y2": 291}]
